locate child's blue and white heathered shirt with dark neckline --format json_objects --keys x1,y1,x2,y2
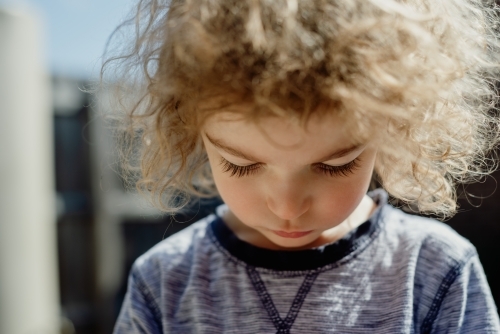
[{"x1": 114, "y1": 191, "x2": 500, "y2": 334}]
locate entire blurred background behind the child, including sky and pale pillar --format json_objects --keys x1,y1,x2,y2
[{"x1": 0, "y1": 0, "x2": 500, "y2": 334}]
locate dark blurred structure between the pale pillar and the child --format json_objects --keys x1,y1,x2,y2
[{"x1": 52, "y1": 77, "x2": 220, "y2": 334}]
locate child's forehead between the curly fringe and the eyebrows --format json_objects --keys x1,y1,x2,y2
[{"x1": 203, "y1": 112, "x2": 361, "y2": 160}]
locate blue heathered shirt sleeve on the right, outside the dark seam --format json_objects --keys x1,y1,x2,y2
[{"x1": 422, "y1": 251, "x2": 500, "y2": 334}]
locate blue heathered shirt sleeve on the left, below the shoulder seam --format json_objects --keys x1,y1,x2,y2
[{"x1": 113, "y1": 266, "x2": 163, "y2": 334}]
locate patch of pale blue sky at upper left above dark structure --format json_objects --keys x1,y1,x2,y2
[{"x1": 0, "y1": 0, "x2": 135, "y2": 79}]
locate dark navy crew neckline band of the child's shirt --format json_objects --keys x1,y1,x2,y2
[{"x1": 210, "y1": 189, "x2": 387, "y2": 271}]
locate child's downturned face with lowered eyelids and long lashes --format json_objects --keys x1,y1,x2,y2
[{"x1": 202, "y1": 108, "x2": 376, "y2": 249}]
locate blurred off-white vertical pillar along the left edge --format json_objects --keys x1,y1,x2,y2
[{"x1": 0, "y1": 8, "x2": 59, "y2": 334}]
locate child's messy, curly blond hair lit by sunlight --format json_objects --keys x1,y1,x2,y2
[{"x1": 101, "y1": 0, "x2": 500, "y2": 217}]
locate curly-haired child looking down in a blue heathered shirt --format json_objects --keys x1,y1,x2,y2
[{"x1": 106, "y1": 0, "x2": 500, "y2": 334}]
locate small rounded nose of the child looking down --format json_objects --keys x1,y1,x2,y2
[{"x1": 267, "y1": 182, "x2": 311, "y2": 220}]
